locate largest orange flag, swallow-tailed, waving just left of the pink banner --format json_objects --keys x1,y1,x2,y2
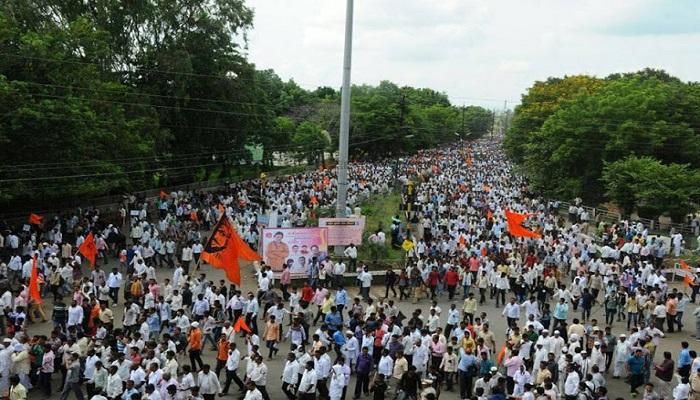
[{"x1": 202, "y1": 215, "x2": 261, "y2": 286}]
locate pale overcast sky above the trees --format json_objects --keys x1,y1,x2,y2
[{"x1": 248, "y1": 0, "x2": 700, "y2": 108}]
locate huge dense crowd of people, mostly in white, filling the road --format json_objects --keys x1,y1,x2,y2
[{"x1": 0, "y1": 141, "x2": 700, "y2": 400}]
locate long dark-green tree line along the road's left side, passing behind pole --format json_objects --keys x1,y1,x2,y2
[{"x1": 0, "y1": 0, "x2": 491, "y2": 211}]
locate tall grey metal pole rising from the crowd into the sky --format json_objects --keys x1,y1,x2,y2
[{"x1": 335, "y1": 0, "x2": 353, "y2": 255}]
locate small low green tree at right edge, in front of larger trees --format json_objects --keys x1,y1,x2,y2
[{"x1": 602, "y1": 156, "x2": 700, "y2": 221}]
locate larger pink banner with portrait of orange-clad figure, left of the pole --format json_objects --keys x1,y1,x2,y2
[{"x1": 262, "y1": 228, "x2": 328, "y2": 274}]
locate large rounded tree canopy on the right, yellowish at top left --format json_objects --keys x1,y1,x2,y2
[{"x1": 516, "y1": 69, "x2": 700, "y2": 203}]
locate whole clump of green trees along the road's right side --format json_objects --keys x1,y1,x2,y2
[{"x1": 506, "y1": 70, "x2": 700, "y2": 218}]
